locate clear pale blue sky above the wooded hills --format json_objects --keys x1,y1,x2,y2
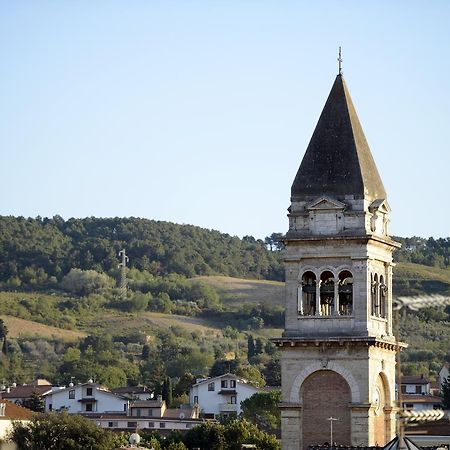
[{"x1": 0, "y1": 0, "x2": 450, "y2": 237}]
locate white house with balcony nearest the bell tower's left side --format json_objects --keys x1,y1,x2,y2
[{"x1": 189, "y1": 373, "x2": 261, "y2": 418}]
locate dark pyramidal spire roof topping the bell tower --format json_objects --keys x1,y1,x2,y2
[{"x1": 291, "y1": 74, "x2": 386, "y2": 200}]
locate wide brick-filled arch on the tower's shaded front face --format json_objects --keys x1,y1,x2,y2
[{"x1": 300, "y1": 370, "x2": 351, "y2": 449}]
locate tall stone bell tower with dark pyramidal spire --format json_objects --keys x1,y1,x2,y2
[{"x1": 275, "y1": 73, "x2": 399, "y2": 450}]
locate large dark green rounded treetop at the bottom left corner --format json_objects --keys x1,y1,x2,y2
[{"x1": 11, "y1": 413, "x2": 125, "y2": 450}]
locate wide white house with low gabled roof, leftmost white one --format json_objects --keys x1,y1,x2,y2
[{"x1": 44, "y1": 381, "x2": 130, "y2": 414}]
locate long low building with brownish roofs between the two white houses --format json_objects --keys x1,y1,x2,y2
[{"x1": 88, "y1": 395, "x2": 202, "y2": 434}]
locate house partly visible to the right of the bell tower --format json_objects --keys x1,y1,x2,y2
[{"x1": 401, "y1": 375, "x2": 442, "y2": 410}]
